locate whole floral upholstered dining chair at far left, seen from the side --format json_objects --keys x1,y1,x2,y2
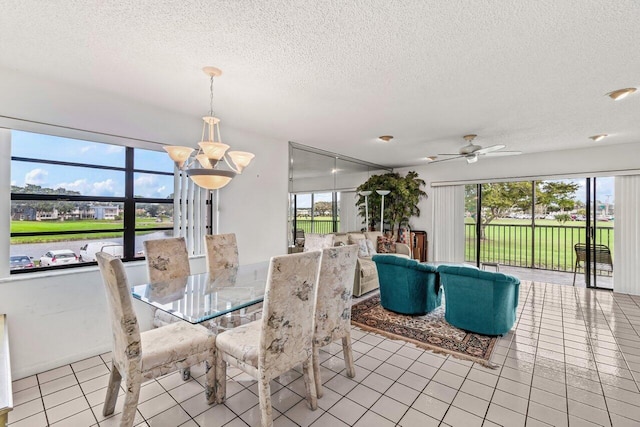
[{"x1": 96, "y1": 252, "x2": 215, "y2": 427}]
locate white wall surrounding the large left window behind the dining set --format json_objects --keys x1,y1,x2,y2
[{"x1": 0, "y1": 68, "x2": 288, "y2": 379}]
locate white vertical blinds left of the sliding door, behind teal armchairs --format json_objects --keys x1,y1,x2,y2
[{"x1": 430, "y1": 185, "x2": 464, "y2": 263}]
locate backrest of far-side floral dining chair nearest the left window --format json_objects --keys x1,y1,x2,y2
[{"x1": 143, "y1": 237, "x2": 191, "y2": 282}]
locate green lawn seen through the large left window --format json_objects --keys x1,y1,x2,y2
[{"x1": 11, "y1": 218, "x2": 173, "y2": 245}]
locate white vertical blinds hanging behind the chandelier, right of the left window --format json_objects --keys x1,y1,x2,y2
[{"x1": 173, "y1": 171, "x2": 209, "y2": 255}]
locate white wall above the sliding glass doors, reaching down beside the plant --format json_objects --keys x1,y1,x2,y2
[{"x1": 396, "y1": 142, "x2": 640, "y2": 270}]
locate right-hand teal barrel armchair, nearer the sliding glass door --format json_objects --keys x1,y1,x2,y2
[{"x1": 438, "y1": 265, "x2": 520, "y2": 335}]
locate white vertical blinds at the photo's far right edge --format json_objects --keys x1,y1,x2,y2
[{"x1": 613, "y1": 175, "x2": 640, "y2": 295}]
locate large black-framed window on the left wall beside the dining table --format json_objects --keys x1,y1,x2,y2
[{"x1": 10, "y1": 131, "x2": 174, "y2": 273}]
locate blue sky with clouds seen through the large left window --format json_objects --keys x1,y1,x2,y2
[{"x1": 11, "y1": 131, "x2": 173, "y2": 198}]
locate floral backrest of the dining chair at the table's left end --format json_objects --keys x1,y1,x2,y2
[{"x1": 96, "y1": 252, "x2": 141, "y2": 372}]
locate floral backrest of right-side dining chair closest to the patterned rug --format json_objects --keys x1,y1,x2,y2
[{"x1": 313, "y1": 245, "x2": 358, "y2": 347}]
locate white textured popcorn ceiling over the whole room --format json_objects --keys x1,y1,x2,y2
[{"x1": 0, "y1": 0, "x2": 640, "y2": 167}]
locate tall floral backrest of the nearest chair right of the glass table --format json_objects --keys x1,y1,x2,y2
[{"x1": 258, "y1": 251, "x2": 322, "y2": 372}]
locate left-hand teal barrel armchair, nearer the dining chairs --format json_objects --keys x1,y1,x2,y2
[{"x1": 373, "y1": 255, "x2": 442, "y2": 315}]
